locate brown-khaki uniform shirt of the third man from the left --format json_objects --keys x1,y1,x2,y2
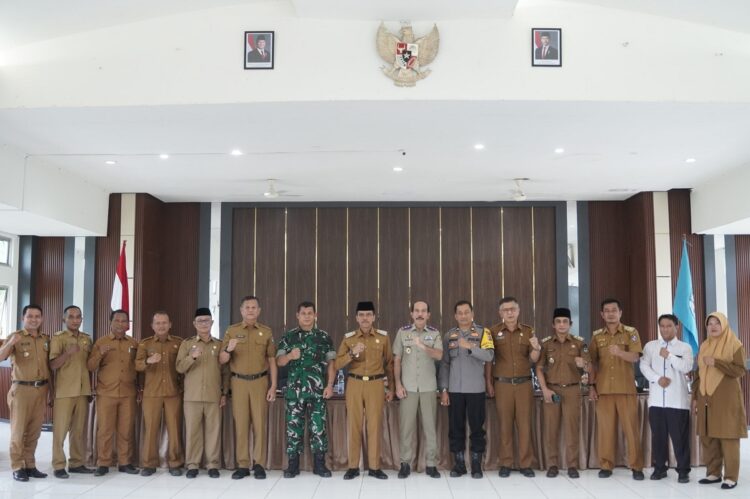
[{"x1": 87, "y1": 333, "x2": 138, "y2": 397}]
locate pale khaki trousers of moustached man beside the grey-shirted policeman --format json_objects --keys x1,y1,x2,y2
[{"x1": 398, "y1": 391, "x2": 437, "y2": 466}]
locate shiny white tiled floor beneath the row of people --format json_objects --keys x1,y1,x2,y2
[{"x1": 0, "y1": 423, "x2": 750, "y2": 499}]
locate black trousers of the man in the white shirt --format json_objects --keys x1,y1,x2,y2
[{"x1": 648, "y1": 407, "x2": 690, "y2": 473}]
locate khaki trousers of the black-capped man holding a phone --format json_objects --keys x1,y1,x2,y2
[{"x1": 542, "y1": 385, "x2": 581, "y2": 468}]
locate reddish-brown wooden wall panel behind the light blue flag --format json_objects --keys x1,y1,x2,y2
[{"x1": 668, "y1": 189, "x2": 706, "y2": 341}]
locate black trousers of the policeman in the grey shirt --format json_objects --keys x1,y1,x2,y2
[{"x1": 448, "y1": 392, "x2": 487, "y2": 454}]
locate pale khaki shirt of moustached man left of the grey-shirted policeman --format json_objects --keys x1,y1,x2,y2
[{"x1": 393, "y1": 324, "x2": 443, "y2": 392}]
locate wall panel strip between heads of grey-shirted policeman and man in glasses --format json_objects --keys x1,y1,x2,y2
[{"x1": 472, "y1": 207, "x2": 503, "y2": 327}]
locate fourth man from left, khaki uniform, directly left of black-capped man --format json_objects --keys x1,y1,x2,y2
[{"x1": 135, "y1": 311, "x2": 183, "y2": 476}]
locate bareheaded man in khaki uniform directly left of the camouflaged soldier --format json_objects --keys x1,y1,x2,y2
[{"x1": 219, "y1": 296, "x2": 278, "y2": 480}]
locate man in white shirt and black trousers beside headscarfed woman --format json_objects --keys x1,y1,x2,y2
[{"x1": 641, "y1": 314, "x2": 693, "y2": 483}]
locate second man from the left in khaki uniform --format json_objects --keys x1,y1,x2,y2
[{"x1": 49, "y1": 305, "x2": 94, "y2": 478}]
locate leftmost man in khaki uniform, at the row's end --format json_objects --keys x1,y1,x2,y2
[{"x1": 0, "y1": 305, "x2": 50, "y2": 482}]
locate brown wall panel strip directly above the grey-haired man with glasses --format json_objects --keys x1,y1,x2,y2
[{"x1": 503, "y1": 207, "x2": 534, "y2": 324}]
